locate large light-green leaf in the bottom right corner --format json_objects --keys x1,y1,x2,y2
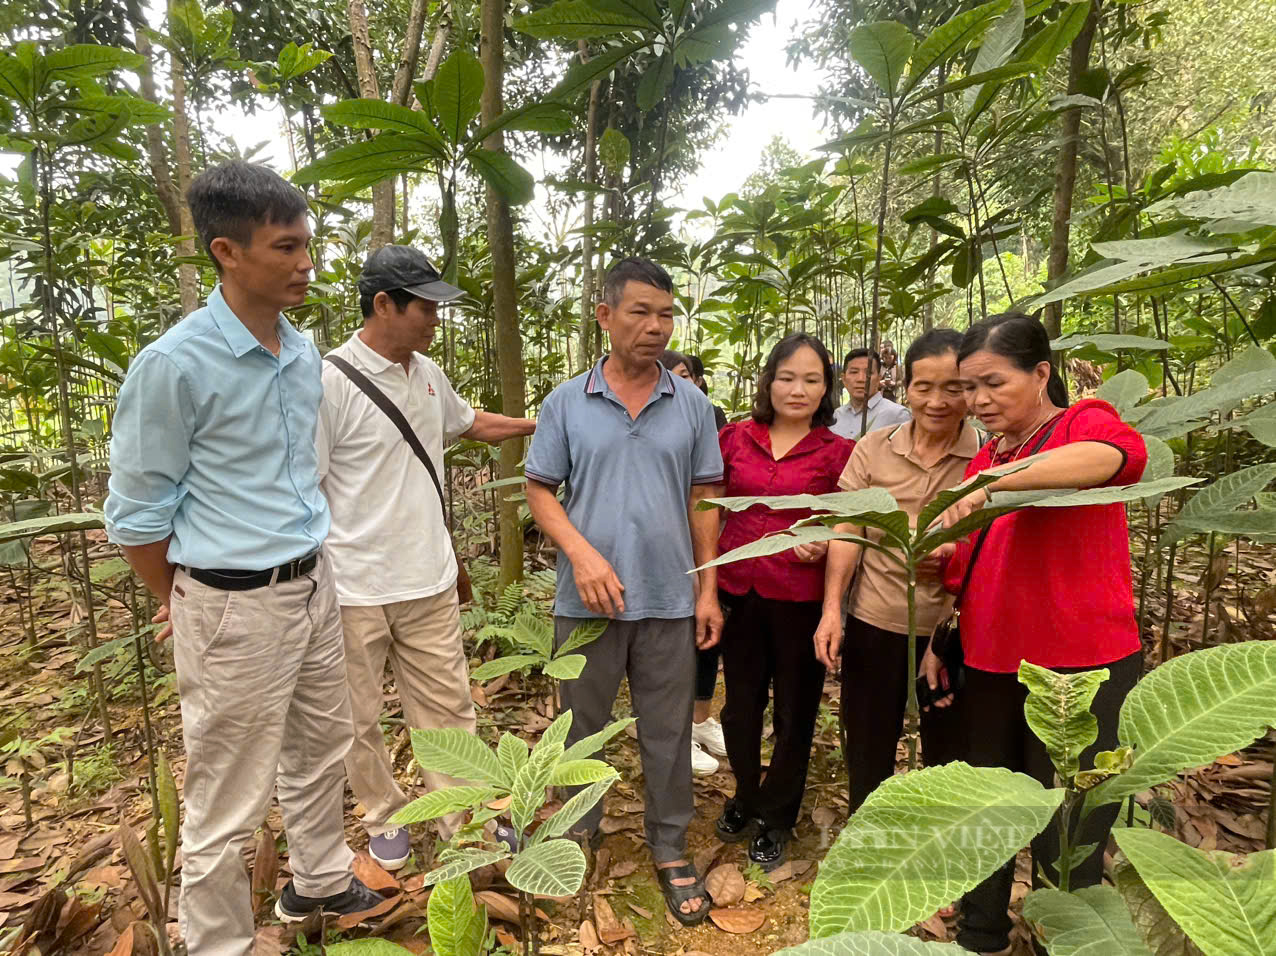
[{"x1": 1113, "y1": 828, "x2": 1276, "y2": 956}]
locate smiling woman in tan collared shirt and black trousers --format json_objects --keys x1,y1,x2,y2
[{"x1": 815, "y1": 328, "x2": 979, "y2": 813}]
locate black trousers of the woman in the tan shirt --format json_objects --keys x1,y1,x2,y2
[{"x1": 841, "y1": 615, "x2": 958, "y2": 813}]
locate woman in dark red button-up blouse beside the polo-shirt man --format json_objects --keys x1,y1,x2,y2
[{"x1": 717, "y1": 333, "x2": 855, "y2": 869}]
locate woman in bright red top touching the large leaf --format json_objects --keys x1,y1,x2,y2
[{"x1": 923, "y1": 313, "x2": 1147, "y2": 952}]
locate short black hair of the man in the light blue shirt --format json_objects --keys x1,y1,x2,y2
[{"x1": 186, "y1": 160, "x2": 310, "y2": 276}]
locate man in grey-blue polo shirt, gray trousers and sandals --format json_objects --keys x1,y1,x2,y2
[{"x1": 526, "y1": 259, "x2": 722, "y2": 925}]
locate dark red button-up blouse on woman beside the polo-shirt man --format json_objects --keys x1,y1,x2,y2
[{"x1": 718, "y1": 419, "x2": 855, "y2": 601}]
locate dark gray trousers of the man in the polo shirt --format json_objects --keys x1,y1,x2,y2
[{"x1": 554, "y1": 618, "x2": 695, "y2": 863}]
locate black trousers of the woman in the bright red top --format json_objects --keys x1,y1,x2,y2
[{"x1": 952, "y1": 651, "x2": 1143, "y2": 952}]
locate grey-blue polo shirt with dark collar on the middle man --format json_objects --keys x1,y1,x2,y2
[{"x1": 526, "y1": 356, "x2": 722, "y2": 620}]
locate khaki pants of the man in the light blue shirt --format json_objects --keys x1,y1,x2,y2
[{"x1": 171, "y1": 556, "x2": 353, "y2": 956}]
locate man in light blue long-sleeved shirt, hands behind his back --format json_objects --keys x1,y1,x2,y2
[{"x1": 106, "y1": 162, "x2": 380, "y2": 956}]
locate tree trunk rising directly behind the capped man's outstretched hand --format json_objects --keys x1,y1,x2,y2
[{"x1": 479, "y1": 0, "x2": 527, "y2": 590}]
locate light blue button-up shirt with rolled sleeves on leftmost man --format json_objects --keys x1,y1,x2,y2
[{"x1": 106, "y1": 286, "x2": 328, "y2": 571}]
